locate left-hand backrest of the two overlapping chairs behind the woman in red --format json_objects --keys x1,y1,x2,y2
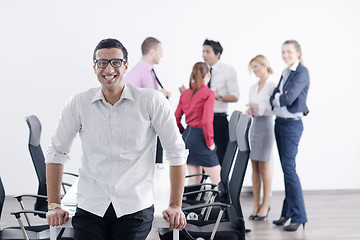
[{"x1": 218, "y1": 111, "x2": 241, "y2": 197}]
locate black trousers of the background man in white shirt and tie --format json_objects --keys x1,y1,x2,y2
[{"x1": 213, "y1": 113, "x2": 229, "y2": 165}]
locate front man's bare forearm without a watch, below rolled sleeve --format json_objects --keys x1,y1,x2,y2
[{"x1": 169, "y1": 164, "x2": 186, "y2": 207}]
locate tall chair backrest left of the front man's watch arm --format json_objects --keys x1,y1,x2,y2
[{"x1": 25, "y1": 115, "x2": 47, "y2": 211}]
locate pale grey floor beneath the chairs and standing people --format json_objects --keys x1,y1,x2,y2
[{"x1": 0, "y1": 190, "x2": 360, "y2": 240}]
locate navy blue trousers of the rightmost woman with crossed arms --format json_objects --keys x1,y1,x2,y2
[{"x1": 275, "y1": 119, "x2": 307, "y2": 223}]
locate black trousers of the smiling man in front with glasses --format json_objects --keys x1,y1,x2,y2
[{"x1": 72, "y1": 204, "x2": 154, "y2": 240}]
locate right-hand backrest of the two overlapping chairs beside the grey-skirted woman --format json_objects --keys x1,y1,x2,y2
[{"x1": 228, "y1": 114, "x2": 252, "y2": 227}]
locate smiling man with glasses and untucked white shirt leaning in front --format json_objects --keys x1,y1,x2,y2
[{"x1": 46, "y1": 39, "x2": 188, "y2": 240}]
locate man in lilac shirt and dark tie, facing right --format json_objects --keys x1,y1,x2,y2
[{"x1": 125, "y1": 37, "x2": 171, "y2": 167}]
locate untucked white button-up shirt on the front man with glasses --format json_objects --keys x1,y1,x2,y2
[{"x1": 46, "y1": 84, "x2": 188, "y2": 217}]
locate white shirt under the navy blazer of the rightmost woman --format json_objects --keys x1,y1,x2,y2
[{"x1": 272, "y1": 60, "x2": 304, "y2": 118}]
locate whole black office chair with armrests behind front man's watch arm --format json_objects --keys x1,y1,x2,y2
[{"x1": 14, "y1": 115, "x2": 78, "y2": 222}]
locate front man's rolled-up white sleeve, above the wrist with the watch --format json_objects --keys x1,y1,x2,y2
[{"x1": 45, "y1": 97, "x2": 80, "y2": 164}]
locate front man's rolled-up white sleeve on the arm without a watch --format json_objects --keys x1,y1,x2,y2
[{"x1": 149, "y1": 92, "x2": 189, "y2": 166}]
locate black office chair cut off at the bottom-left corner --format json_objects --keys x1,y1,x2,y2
[{"x1": 0, "y1": 177, "x2": 74, "y2": 240}]
